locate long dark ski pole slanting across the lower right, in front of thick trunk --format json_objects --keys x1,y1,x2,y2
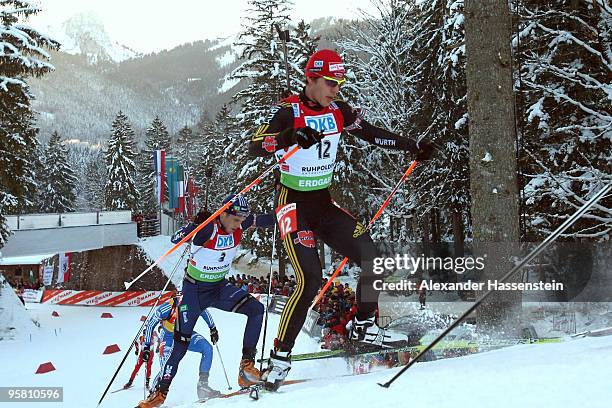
[{"x1": 378, "y1": 182, "x2": 612, "y2": 388}]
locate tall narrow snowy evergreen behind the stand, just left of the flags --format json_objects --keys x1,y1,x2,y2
[{"x1": 105, "y1": 111, "x2": 138, "y2": 211}]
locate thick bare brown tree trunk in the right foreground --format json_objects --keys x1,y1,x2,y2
[{"x1": 465, "y1": 0, "x2": 521, "y2": 335}]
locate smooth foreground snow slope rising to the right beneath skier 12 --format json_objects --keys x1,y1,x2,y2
[{"x1": 180, "y1": 337, "x2": 612, "y2": 408}]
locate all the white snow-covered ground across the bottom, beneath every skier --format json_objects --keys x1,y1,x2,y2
[{"x1": 0, "y1": 298, "x2": 612, "y2": 408}]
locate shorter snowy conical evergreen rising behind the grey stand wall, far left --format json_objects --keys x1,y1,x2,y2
[{"x1": 41, "y1": 132, "x2": 77, "y2": 213}]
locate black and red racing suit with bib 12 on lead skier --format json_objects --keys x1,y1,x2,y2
[{"x1": 249, "y1": 91, "x2": 416, "y2": 351}]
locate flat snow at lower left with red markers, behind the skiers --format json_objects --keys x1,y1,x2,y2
[{"x1": 0, "y1": 294, "x2": 328, "y2": 407}]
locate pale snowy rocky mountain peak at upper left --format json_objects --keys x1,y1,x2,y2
[{"x1": 49, "y1": 11, "x2": 138, "y2": 64}]
